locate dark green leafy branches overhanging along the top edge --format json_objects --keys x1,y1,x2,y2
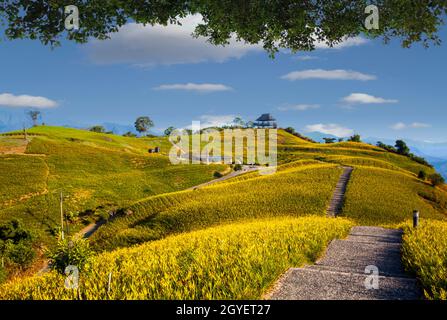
[{"x1": 0, "y1": 0, "x2": 447, "y2": 53}]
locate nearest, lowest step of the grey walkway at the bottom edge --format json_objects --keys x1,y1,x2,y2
[{"x1": 266, "y1": 268, "x2": 422, "y2": 300}]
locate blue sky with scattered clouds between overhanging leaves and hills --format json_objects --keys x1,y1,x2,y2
[{"x1": 0, "y1": 18, "x2": 447, "y2": 142}]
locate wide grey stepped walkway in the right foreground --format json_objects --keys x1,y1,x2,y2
[{"x1": 266, "y1": 227, "x2": 422, "y2": 300}]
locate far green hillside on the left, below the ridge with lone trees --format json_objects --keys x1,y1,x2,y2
[{"x1": 0, "y1": 126, "x2": 225, "y2": 241}]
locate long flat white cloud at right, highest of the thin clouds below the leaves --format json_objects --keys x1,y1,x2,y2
[{"x1": 281, "y1": 69, "x2": 376, "y2": 81}]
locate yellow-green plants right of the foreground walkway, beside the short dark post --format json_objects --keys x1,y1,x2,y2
[{"x1": 402, "y1": 220, "x2": 447, "y2": 300}]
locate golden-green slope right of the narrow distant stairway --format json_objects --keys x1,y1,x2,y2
[{"x1": 343, "y1": 166, "x2": 447, "y2": 227}]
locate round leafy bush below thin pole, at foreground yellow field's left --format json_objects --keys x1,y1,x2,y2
[{"x1": 47, "y1": 238, "x2": 93, "y2": 274}]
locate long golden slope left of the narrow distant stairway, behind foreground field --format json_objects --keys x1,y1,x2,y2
[{"x1": 92, "y1": 164, "x2": 341, "y2": 250}]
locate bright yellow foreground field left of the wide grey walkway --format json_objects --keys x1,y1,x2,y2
[{"x1": 0, "y1": 217, "x2": 352, "y2": 300}]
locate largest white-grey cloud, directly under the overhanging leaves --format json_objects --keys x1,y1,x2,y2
[{"x1": 87, "y1": 15, "x2": 263, "y2": 66}]
